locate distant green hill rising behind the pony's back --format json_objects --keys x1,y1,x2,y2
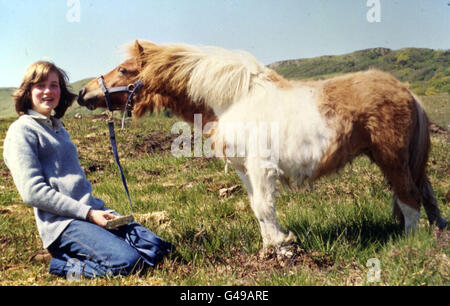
[{"x1": 269, "y1": 48, "x2": 450, "y2": 95}]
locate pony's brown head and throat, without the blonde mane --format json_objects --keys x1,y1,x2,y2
[{"x1": 78, "y1": 40, "x2": 220, "y2": 123}]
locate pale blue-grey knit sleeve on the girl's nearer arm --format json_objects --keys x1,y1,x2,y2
[{"x1": 3, "y1": 125, "x2": 91, "y2": 220}]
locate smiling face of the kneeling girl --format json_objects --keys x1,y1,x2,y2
[{"x1": 31, "y1": 71, "x2": 61, "y2": 118}]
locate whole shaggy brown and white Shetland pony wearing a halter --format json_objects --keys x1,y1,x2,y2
[{"x1": 78, "y1": 41, "x2": 446, "y2": 253}]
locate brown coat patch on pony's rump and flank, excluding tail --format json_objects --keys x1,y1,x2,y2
[{"x1": 315, "y1": 70, "x2": 416, "y2": 177}]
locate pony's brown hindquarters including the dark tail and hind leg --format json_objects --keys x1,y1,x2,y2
[{"x1": 314, "y1": 70, "x2": 435, "y2": 220}]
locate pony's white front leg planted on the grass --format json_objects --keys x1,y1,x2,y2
[{"x1": 247, "y1": 160, "x2": 296, "y2": 255}]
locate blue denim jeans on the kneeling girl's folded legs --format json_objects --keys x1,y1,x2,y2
[{"x1": 48, "y1": 220, "x2": 173, "y2": 278}]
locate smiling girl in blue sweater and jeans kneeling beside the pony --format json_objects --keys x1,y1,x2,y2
[{"x1": 3, "y1": 61, "x2": 172, "y2": 278}]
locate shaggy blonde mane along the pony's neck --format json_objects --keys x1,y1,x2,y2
[{"x1": 129, "y1": 41, "x2": 274, "y2": 113}]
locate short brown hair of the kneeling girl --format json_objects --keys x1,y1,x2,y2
[{"x1": 13, "y1": 61, "x2": 77, "y2": 118}]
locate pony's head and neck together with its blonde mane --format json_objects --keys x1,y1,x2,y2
[{"x1": 78, "y1": 41, "x2": 287, "y2": 122}]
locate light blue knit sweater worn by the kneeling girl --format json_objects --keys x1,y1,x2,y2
[{"x1": 3, "y1": 111, "x2": 106, "y2": 248}]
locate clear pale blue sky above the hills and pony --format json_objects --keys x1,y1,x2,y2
[{"x1": 0, "y1": 0, "x2": 450, "y2": 87}]
